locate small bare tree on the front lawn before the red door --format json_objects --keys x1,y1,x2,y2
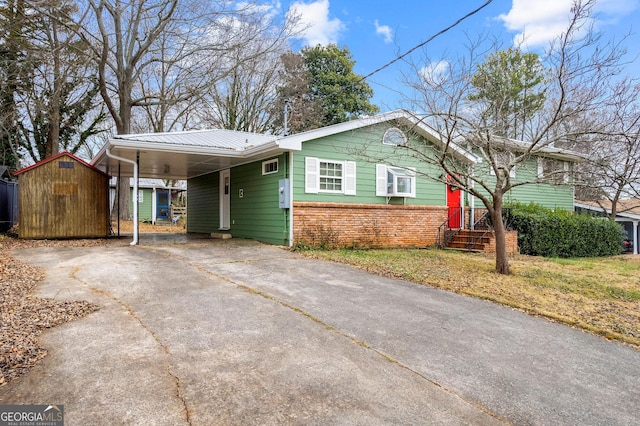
[{"x1": 400, "y1": 0, "x2": 624, "y2": 274}]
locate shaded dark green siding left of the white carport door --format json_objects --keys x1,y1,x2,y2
[{"x1": 187, "y1": 173, "x2": 220, "y2": 234}]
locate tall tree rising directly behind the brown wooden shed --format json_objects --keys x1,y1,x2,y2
[{"x1": 16, "y1": 0, "x2": 104, "y2": 162}]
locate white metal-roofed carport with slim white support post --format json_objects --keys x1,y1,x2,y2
[{"x1": 91, "y1": 129, "x2": 302, "y2": 245}]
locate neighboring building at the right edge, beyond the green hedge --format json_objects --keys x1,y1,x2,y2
[{"x1": 575, "y1": 198, "x2": 640, "y2": 254}]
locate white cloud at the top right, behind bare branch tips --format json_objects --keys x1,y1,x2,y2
[{"x1": 498, "y1": 0, "x2": 638, "y2": 47}]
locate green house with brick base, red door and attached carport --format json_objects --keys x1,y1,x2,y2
[{"x1": 92, "y1": 111, "x2": 573, "y2": 247}]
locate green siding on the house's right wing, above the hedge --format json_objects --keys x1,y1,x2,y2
[{"x1": 475, "y1": 157, "x2": 574, "y2": 210}]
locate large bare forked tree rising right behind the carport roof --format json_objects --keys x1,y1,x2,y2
[{"x1": 79, "y1": 0, "x2": 294, "y2": 219}]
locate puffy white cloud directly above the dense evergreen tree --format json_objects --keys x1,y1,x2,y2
[{"x1": 287, "y1": 0, "x2": 345, "y2": 46}]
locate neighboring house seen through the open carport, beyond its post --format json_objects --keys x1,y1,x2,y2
[{"x1": 109, "y1": 178, "x2": 186, "y2": 224}]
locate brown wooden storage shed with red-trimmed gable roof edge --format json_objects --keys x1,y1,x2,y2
[{"x1": 14, "y1": 152, "x2": 110, "y2": 239}]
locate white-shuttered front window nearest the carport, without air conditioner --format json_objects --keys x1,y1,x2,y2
[{"x1": 305, "y1": 157, "x2": 356, "y2": 195}]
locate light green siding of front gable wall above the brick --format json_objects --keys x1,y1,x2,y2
[{"x1": 293, "y1": 125, "x2": 446, "y2": 206}]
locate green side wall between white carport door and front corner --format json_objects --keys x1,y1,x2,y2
[{"x1": 230, "y1": 154, "x2": 289, "y2": 245}]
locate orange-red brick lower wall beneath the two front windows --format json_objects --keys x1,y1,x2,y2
[{"x1": 293, "y1": 202, "x2": 447, "y2": 247}]
